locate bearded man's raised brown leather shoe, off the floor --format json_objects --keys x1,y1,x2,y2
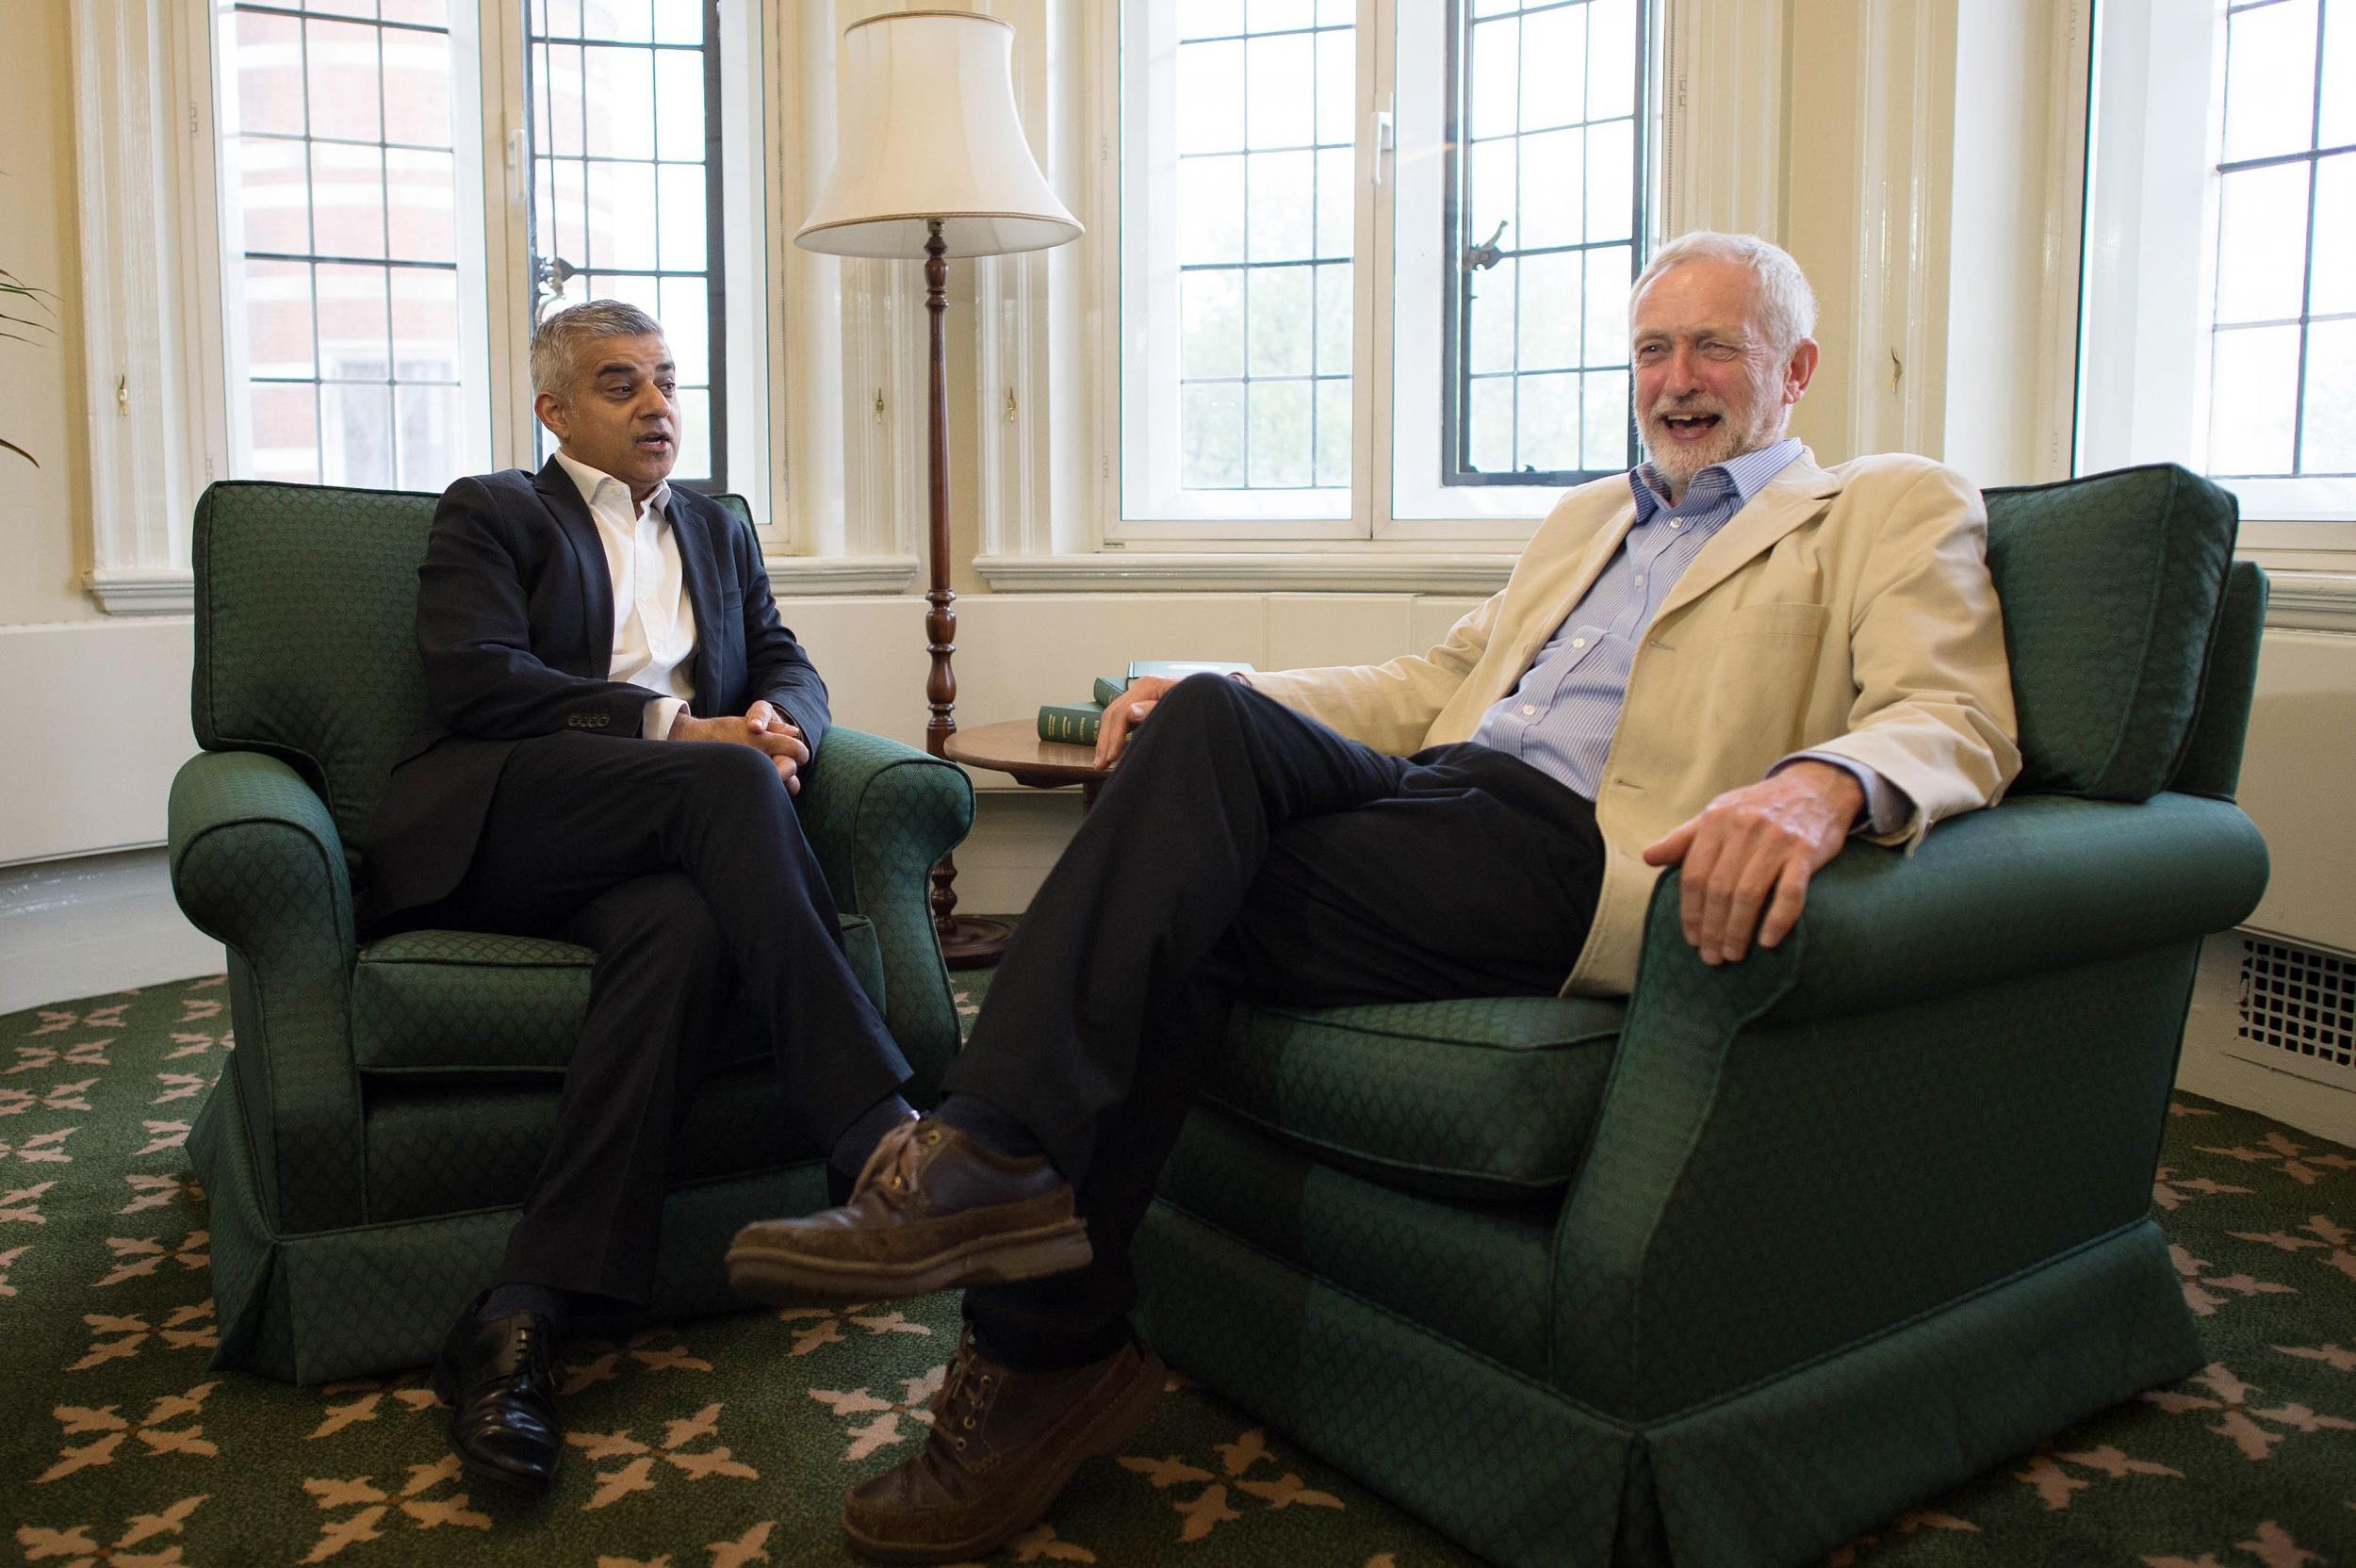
[{"x1": 728, "y1": 1116, "x2": 1091, "y2": 1304}]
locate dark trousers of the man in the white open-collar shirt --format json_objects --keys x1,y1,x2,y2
[{"x1": 382, "y1": 735, "x2": 909, "y2": 1304}]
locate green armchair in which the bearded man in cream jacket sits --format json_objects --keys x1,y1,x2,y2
[{"x1": 1136, "y1": 466, "x2": 2266, "y2": 1568}]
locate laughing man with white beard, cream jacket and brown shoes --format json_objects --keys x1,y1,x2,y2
[{"x1": 730, "y1": 233, "x2": 2020, "y2": 1561}]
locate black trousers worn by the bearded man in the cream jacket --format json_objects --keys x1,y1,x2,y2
[{"x1": 942, "y1": 676, "x2": 1602, "y2": 1370}]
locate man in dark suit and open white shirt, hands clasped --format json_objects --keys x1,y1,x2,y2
[{"x1": 363, "y1": 302, "x2": 912, "y2": 1488}]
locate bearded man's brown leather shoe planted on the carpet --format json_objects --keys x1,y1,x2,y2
[{"x1": 843, "y1": 1331, "x2": 1169, "y2": 1563}]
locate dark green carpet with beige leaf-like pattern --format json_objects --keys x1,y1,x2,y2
[{"x1": 0, "y1": 977, "x2": 2356, "y2": 1568}]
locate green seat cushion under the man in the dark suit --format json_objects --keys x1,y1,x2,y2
[{"x1": 352, "y1": 916, "x2": 884, "y2": 1073}]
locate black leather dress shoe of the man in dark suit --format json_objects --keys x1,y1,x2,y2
[{"x1": 434, "y1": 1298, "x2": 565, "y2": 1493}]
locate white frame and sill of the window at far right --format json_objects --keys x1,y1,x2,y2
[{"x1": 2076, "y1": 0, "x2": 2356, "y2": 553}]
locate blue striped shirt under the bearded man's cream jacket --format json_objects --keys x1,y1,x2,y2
[{"x1": 1473, "y1": 438, "x2": 1913, "y2": 831}]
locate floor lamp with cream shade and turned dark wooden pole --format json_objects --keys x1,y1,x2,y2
[{"x1": 794, "y1": 11, "x2": 1082, "y2": 968}]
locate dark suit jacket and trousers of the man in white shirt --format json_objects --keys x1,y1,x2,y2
[{"x1": 361, "y1": 457, "x2": 909, "y2": 1302}]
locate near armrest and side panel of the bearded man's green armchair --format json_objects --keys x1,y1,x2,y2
[{"x1": 1555, "y1": 793, "x2": 2266, "y2": 1420}]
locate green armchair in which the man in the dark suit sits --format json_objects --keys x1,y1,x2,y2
[{"x1": 170, "y1": 482, "x2": 973, "y2": 1382}]
